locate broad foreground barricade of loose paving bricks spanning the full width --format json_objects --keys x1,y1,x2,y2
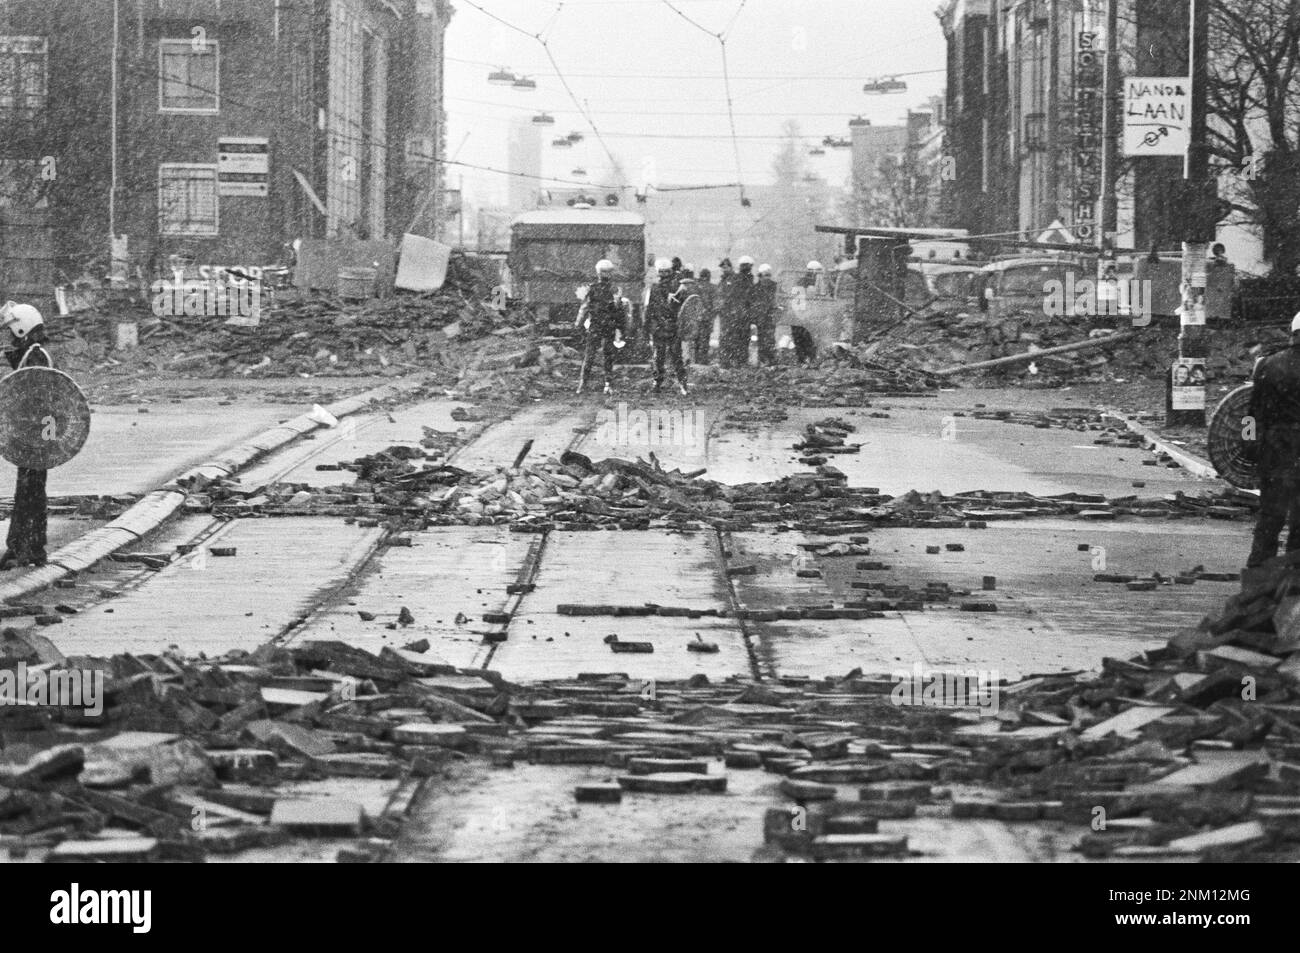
[{"x1": 0, "y1": 541, "x2": 1300, "y2": 862}]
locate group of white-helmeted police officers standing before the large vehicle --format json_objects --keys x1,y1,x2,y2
[{"x1": 575, "y1": 255, "x2": 781, "y2": 397}]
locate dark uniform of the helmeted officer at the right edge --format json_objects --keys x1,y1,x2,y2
[{"x1": 1247, "y1": 337, "x2": 1300, "y2": 567}]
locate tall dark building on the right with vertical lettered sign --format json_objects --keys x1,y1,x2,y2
[{"x1": 939, "y1": 0, "x2": 1261, "y2": 270}]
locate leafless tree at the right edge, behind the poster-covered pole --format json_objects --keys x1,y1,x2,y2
[{"x1": 1208, "y1": 0, "x2": 1300, "y2": 274}]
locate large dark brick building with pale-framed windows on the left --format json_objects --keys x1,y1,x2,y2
[{"x1": 0, "y1": 0, "x2": 451, "y2": 293}]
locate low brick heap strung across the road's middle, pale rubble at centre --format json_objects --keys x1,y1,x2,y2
[{"x1": 178, "y1": 439, "x2": 1255, "y2": 536}]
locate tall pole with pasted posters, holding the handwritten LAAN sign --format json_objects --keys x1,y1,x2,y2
[{"x1": 1166, "y1": 0, "x2": 1217, "y2": 426}]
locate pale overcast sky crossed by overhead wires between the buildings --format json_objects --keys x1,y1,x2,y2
[{"x1": 446, "y1": 0, "x2": 945, "y2": 204}]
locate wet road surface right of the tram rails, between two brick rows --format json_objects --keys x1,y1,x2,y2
[{"x1": 731, "y1": 520, "x2": 1249, "y2": 679}]
